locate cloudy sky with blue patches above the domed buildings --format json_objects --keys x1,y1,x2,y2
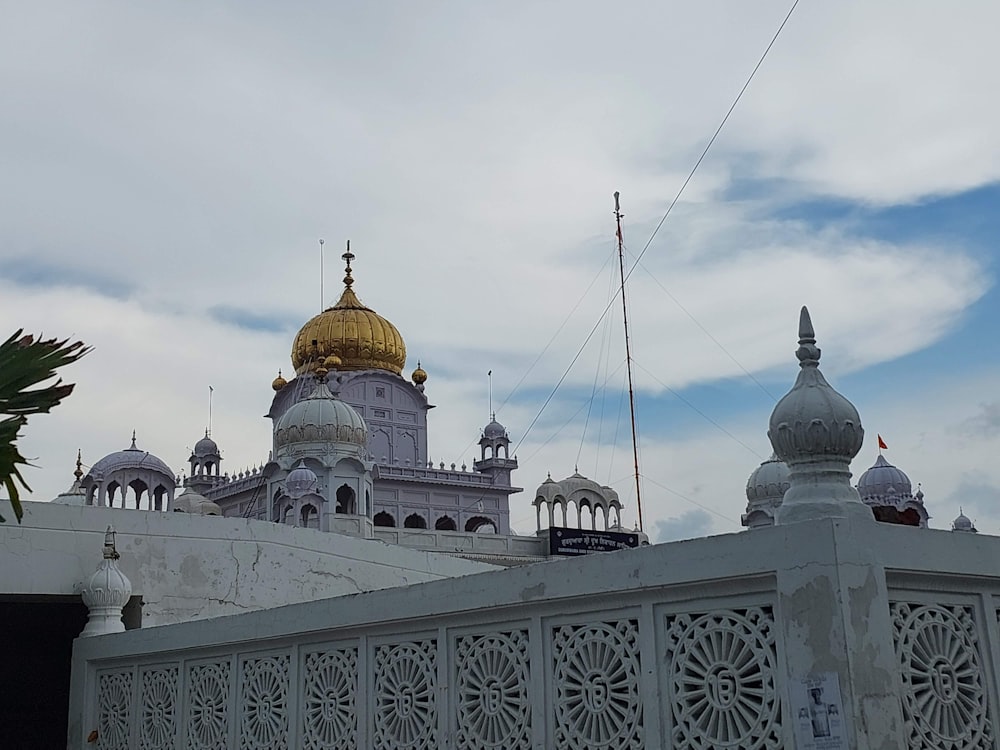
[{"x1": 0, "y1": 0, "x2": 1000, "y2": 541}]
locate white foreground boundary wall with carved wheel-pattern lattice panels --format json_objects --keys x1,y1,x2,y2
[{"x1": 69, "y1": 518, "x2": 1000, "y2": 750}]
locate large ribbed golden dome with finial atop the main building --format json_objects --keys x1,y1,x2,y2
[{"x1": 292, "y1": 243, "x2": 406, "y2": 375}]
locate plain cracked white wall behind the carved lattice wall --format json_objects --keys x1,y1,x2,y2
[{"x1": 0, "y1": 502, "x2": 495, "y2": 628}]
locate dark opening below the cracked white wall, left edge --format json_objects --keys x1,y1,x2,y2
[{"x1": 0, "y1": 596, "x2": 87, "y2": 750}]
